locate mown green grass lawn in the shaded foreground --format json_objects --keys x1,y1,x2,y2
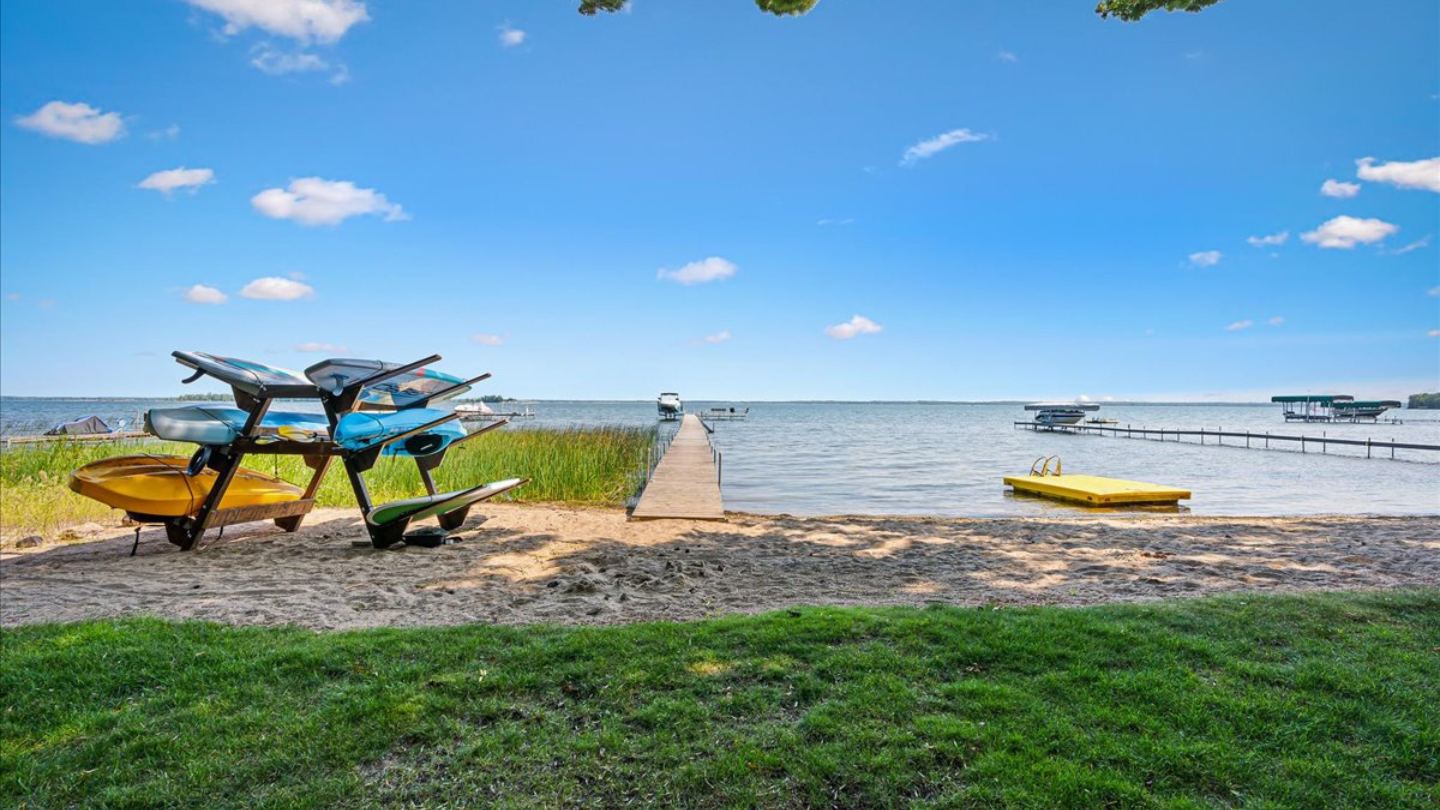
[{"x1": 0, "y1": 589, "x2": 1440, "y2": 809}]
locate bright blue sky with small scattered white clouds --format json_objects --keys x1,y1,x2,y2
[{"x1": 0, "y1": 0, "x2": 1440, "y2": 401}]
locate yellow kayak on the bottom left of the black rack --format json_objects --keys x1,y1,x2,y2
[{"x1": 71, "y1": 455, "x2": 304, "y2": 517}]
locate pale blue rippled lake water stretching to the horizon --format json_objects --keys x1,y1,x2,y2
[{"x1": 0, "y1": 398, "x2": 1440, "y2": 517}]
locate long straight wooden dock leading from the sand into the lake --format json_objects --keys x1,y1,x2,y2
[{"x1": 631, "y1": 414, "x2": 724, "y2": 520}]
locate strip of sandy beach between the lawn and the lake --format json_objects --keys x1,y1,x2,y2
[{"x1": 0, "y1": 504, "x2": 1440, "y2": 630}]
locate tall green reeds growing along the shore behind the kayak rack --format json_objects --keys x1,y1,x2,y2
[{"x1": 0, "y1": 428, "x2": 654, "y2": 538}]
